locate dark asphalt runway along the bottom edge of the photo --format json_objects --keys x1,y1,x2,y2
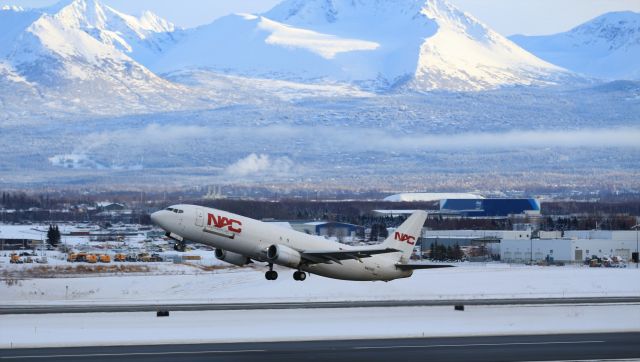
[{"x1": 0, "y1": 334, "x2": 640, "y2": 362}]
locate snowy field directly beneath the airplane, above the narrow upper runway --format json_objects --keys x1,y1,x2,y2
[{"x1": 0, "y1": 263, "x2": 640, "y2": 305}]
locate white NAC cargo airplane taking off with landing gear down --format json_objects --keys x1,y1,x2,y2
[{"x1": 151, "y1": 204, "x2": 450, "y2": 282}]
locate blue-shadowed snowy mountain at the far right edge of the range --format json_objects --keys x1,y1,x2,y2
[{"x1": 511, "y1": 11, "x2": 640, "y2": 80}]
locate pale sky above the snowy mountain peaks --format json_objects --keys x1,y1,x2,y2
[{"x1": 0, "y1": 0, "x2": 640, "y2": 35}]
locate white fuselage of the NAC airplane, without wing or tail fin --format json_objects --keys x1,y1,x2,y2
[{"x1": 152, "y1": 205, "x2": 412, "y2": 281}]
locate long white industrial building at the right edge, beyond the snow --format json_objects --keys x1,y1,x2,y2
[{"x1": 500, "y1": 230, "x2": 638, "y2": 263}]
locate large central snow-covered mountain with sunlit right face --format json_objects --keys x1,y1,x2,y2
[{"x1": 151, "y1": 0, "x2": 566, "y2": 90}]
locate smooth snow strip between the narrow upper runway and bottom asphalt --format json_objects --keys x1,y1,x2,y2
[{"x1": 0, "y1": 304, "x2": 640, "y2": 348}]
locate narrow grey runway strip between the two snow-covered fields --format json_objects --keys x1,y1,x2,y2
[{"x1": 0, "y1": 297, "x2": 640, "y2": 315}]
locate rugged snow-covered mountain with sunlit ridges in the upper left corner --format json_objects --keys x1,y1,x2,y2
[{"x1": 0, "y1": 0, "x2": 202, "y2": 113}]
